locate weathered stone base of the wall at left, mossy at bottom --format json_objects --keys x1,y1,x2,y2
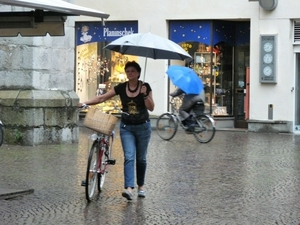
[{"x1": 0, "y1": 90, "x2": 79, "y2": 145}]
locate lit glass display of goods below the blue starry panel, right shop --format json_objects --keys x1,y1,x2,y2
[{"x1": 182, "y1": 42, "x2": 232, "y2": 116}]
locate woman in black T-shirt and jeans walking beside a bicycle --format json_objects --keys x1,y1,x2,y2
[{"x1": 78, "y1": 61, "x2": 154, "y2": 200}]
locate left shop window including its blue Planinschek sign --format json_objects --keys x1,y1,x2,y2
[{"x1": 75, "y1": 21, "x2": 138, "y2": 113}]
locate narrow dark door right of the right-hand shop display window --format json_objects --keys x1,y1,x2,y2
[{"x1": 234, "y1": 46, "x2": 249, "y2": 128}]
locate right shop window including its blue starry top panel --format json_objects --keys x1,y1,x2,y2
[{"x1": 169, "y1": 20, "x2": 250, "y2": 117}]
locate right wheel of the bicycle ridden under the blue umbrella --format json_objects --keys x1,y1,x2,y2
[{"x1": 194, "y1": 115, "x2": 216, "y2": 143}]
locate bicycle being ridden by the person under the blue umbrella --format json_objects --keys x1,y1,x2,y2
[{"x1": 156, "y1": 97, "x2": 216, "y2": 143}]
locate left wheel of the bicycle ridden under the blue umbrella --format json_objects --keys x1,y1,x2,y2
[{"x1": 156, "y1": 113, "x2": 178, "y2": 141}]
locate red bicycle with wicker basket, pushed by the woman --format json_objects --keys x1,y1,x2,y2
[{"x1": 82, "y1": 105, "x2": 118, "y2": 201}]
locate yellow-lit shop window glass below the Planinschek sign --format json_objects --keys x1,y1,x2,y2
[{"x1": 76, "y1": 42, "x2": 137, "y2": 113}]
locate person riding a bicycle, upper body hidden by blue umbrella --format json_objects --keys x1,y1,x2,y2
[{"x1": 169, "y1": 88, "x2": 205, "y2": 132}]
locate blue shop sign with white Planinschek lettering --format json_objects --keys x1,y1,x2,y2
[{"x1": 75, "y1": 21, "x2": 138, "y2": 45}]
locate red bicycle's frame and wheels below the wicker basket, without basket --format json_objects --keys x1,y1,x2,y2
[{"x1": 81, "y1": 104, "x2": 116, "y2": 202}]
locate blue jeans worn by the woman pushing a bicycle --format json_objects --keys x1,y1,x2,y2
[{"x1": 120, "y1": 122, "x2": 151, "y2": 189}]
